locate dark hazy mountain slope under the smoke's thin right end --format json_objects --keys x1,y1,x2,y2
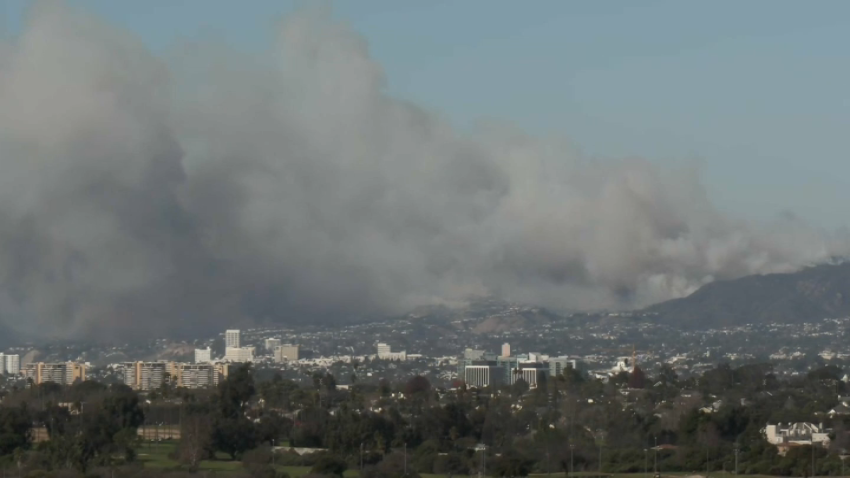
[{"x1": 644, "y1": 262, "x2": 850, "y2": 329}]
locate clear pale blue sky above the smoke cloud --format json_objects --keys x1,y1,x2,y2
[{"x1": 0, "y1": 0, "x2": 850, "y2": 228}]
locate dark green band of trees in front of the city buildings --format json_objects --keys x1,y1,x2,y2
[{"x1": 0, "y1": 364, "x2": 850, "y2": 478}]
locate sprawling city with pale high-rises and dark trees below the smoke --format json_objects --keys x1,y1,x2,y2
[{"x1": 0, "y1": 300, "x2": 850, "y2": 477}]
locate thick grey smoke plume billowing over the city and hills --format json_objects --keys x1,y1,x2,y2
[{"x1": 0, "y1": 3, "x2": 847, "y2": 337}]
